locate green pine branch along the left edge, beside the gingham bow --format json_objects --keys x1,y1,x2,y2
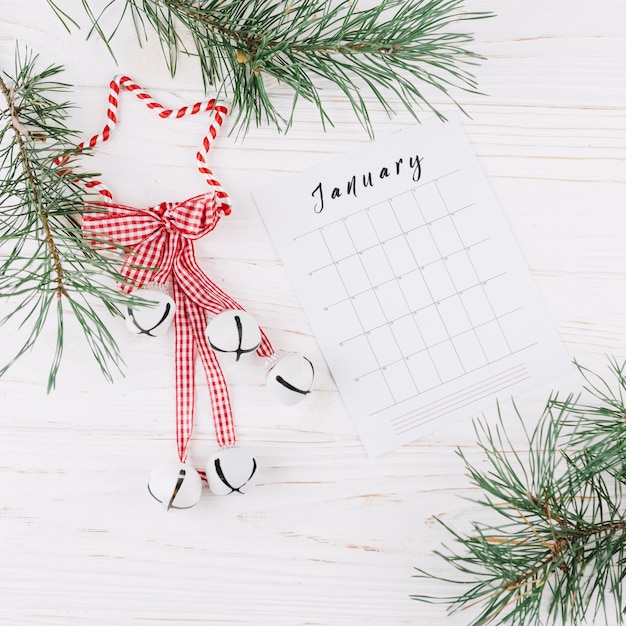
[{"x1": 0, "y1": 50, "x2": 136, "y2": 390}]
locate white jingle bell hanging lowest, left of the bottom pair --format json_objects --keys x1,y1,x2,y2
[{"x1": 148, "y1": 462, "x2": 202, "y2": 511}]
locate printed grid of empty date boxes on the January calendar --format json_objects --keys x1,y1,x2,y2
[{"x1": 295, "y1": 170, "x2": 534, "y2": 414}]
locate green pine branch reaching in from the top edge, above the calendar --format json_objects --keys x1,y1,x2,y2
[{"x1": 48, "y1": 0, "x2": 491, "y2": 135}]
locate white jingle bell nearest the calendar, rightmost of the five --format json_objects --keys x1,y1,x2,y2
[{"x1": 267, "y1": 354, "x2": 315, "y2": 406}]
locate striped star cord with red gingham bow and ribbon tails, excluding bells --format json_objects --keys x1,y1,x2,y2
[{"x1": 75, "y1": 76, "x2": 274, "y2": 462}]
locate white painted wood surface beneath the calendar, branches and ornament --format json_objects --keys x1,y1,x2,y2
[{"x1": 0, "y1": 0, "x2": 626, "y2": 626}]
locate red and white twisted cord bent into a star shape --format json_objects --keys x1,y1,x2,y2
[{"x1": 54, "y1": 76, "x2": 230, "y2": 215}]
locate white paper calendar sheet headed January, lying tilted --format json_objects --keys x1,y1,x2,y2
[{"x1": 254, "y1": 120, "x2": 570, "y2": 456}]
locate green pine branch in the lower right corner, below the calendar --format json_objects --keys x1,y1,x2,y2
[{"x1": 412, "y1": 361, "x2": 626, "y2": 626}]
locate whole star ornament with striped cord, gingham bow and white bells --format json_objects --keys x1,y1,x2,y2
[{"x1": 65, "y1": 76, "x2": 308, "y2": 509}]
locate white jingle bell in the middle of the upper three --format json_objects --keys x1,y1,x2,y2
[{"x1": 206, "y1": 309, "x2": 261, "y2": 361}]
